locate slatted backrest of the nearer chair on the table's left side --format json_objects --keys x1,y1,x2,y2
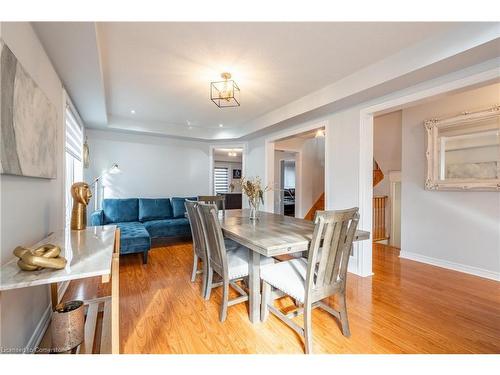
[{"x1": 197, "y1": 202, "x2": 228, "y2": 278}]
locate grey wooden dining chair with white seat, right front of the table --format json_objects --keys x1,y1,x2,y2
[{"x1": 260, "y1": 207, "x2": 359, "y2": 353}]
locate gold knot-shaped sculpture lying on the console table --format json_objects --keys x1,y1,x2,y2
[{"x1": 14, "y1": 244, "x2": 66, "y2": 271}]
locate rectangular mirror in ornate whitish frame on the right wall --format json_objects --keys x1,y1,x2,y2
[{"x1": 424, "y1": 105, "x2": 500, "y2": 191}]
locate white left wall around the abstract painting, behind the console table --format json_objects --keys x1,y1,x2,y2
[{"x1": 0, "y1": 22, "x2": 64, "y2": 348}]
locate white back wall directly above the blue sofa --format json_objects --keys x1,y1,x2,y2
[{"x1": 84, "y1": 129, "x2": 210, "y2": 206}]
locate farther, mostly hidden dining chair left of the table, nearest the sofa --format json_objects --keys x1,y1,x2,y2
[{"x1": 185, "y1": 200, "x2": 208, "y2": 297}]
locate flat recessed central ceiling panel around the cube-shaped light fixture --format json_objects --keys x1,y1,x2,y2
[{"x1": 98, "y1": 22, "x2": 458, "y2": 128}]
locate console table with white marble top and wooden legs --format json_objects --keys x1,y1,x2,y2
[{"x1": 0, "y1": 225, "x2": 120, "y2": 354}]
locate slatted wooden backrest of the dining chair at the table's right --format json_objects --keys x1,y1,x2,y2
[{"x1": 306, "y1": 207, "x2": 359, "y2": 302}]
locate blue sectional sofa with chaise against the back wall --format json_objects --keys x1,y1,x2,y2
[{"x1": 90, "y1": 197, "x2": 196, "y2": 263}]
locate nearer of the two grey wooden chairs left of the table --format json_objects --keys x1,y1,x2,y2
[{"x1": 197, "y1": 203, "x2": 273, "y2": 322}]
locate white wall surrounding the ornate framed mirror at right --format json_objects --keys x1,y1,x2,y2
[{"x1": 401, "y1": 84, "x2": 500, "y2": 276}]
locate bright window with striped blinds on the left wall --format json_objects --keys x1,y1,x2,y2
[{"x1": 64, "y1": 103, "x2": 83, "y2": 226}]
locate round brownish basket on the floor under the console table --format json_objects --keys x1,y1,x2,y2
[{"x1": 51, "y1": 301, "x2": 85, "y2": 353}]
